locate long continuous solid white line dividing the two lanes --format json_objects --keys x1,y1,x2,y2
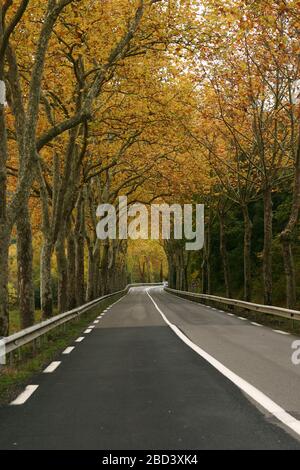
[{"x1": 147, "y1": 289, "x2": 300, "y2": 436}]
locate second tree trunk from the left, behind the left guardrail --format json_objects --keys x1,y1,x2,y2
[{"x1": 17, "y1": 205, "x2": 35, "y2": 329}]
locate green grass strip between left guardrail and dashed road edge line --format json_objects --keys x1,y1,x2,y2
[{"x1": 0, "y1": 295, "x2": 122, "y2": 405}]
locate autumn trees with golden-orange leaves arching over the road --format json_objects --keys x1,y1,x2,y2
[{"x1": 0, "y1": 0, "x2": 300, "y2": 336}]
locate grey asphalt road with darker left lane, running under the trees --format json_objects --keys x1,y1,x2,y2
[{"x1": 0, "y1": 288, "x2": 300, "y2": 450}]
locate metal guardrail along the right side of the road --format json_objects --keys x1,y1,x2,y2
[{"x1": 165, "y1": 287, "x2": 300, "y2": 320}]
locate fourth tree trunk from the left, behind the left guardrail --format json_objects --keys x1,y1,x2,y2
[{"x1": 55, "y1": 232, "x2": 68, "y2": 313}]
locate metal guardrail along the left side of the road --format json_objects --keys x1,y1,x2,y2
[{"x1": 2, "y1": 283, "x2": 162, "y2": 354}]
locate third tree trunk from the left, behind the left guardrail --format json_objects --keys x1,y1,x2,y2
[{"x1": 41, "y1": 240, "x2": 53, "y2": 319}]
